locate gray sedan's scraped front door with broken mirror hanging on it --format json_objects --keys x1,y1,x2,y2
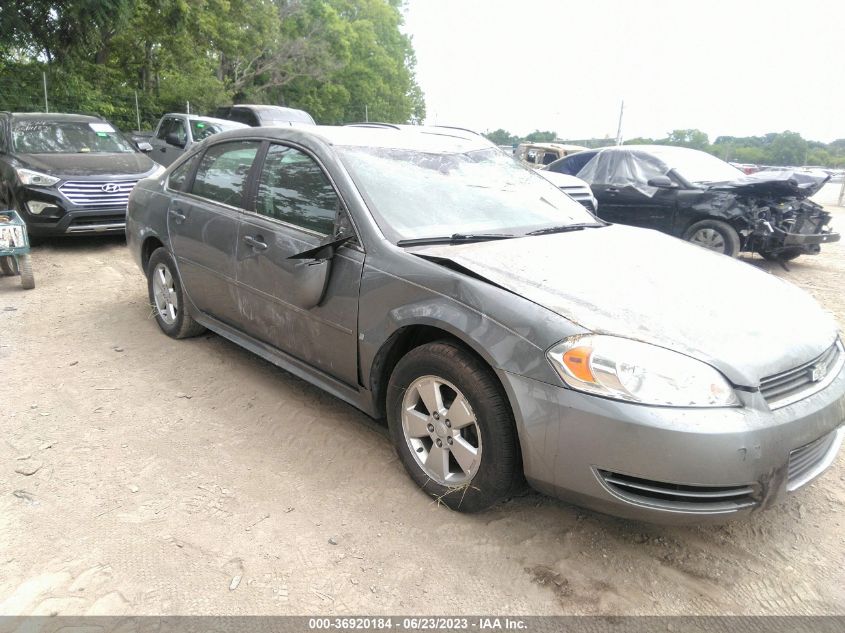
[{"x1": 237, "y1": 143, "x2": 364, "y2": 385}]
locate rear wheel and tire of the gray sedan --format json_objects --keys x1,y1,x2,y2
[{"x1": 147, "y1": 247, "x2": 205, "y2": 339}]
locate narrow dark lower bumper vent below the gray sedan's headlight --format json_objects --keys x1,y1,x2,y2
[{"x1": 598, "y1": 470, "x2": 757, "y2": 512}]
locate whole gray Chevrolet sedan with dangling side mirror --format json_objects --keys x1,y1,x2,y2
[{"x1": 127, "y1": 126, "x2": 845, "y2": 521}]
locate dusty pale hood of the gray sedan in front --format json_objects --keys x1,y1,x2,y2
[{"x1": 414, "y1": 225, "x2": 837, "y2": 387}]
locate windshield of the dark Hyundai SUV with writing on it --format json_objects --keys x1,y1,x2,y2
[{"x1": 12, "y1": 121, "x2": 135, "y2": 154}]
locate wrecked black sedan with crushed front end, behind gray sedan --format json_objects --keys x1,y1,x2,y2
[{"x1": 548, "y1": 145, "x2": 839, "y2": 261}]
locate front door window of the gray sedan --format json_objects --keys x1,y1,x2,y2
[{"x1": 255, "y1": 145, "x2": 340, "y2": 235}]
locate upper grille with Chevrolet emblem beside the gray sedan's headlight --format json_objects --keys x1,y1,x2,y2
[{"x1": 760, "y1": 341, "x2": 845, "y2": 409}]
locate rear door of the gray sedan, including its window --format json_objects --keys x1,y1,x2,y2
[{"x1": 167, "y1": 140, "x2": 261, "y2": 325}]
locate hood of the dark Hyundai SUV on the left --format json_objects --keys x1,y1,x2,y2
[{"x1": 17, "y1": 152, "x2": 155, "y2": 177}]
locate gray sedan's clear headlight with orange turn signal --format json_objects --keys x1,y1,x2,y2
[{"x1": 546, "y1": 335, "x2": 739, "y2": 407}]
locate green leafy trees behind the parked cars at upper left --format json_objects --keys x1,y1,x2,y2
[{"x1": 0, "y1": 0, "x2": 425, "y2": 127}]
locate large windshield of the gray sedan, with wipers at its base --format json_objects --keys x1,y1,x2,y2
[{"x1": 338, "y1": 147, "x2": 596, "y2": 241}]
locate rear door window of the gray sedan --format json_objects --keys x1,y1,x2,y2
[{"x1": 190, "y1": 141, "x2": 259, "y2": 207}]
